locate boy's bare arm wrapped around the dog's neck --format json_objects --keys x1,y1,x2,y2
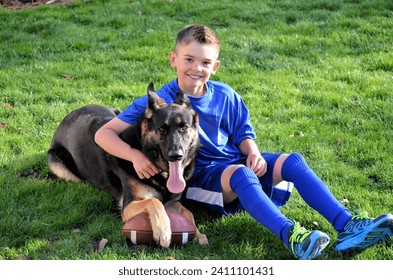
[{"x1": 94, "y1": 118, "x2": 158, "y2": 179}]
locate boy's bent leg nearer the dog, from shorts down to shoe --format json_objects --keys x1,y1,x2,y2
[{"x1": 184, "y1": 161, "x2": 329, "y2": 259}]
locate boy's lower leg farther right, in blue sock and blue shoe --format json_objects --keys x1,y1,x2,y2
[{"x1": 281, "y1": 153, "x2": 393, "y2": 251}]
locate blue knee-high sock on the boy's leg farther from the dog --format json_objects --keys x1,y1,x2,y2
[{"x1": 281, "y1": 153, "x2": 352, "y2": 231}]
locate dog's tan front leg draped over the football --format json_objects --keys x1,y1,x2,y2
[{"x1": 122, "y1": 198, "x2": 172, "y2": 248}]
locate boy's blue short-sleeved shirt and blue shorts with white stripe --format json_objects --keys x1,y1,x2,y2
[{"x1": 118, "y1": 80, "x2": 292, "y2": 214}]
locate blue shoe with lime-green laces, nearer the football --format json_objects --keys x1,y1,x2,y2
[{"x1": 289, "y1": 223, "x2": 330, "y2": 260}]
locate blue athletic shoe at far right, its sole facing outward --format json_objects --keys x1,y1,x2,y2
[{"x1": 336, "y1": 211, "x2": 393, "y2": 251}]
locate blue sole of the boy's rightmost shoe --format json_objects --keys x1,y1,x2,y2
[{"x1": 336, "y1": 214, "x2": 393, "y2": 251}]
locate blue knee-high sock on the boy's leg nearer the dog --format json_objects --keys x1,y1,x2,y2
[{"x1": 229, "y1": 166, "x2": 293, "y2": 246}]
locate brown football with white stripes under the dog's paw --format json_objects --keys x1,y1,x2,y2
[{"x1": 123, "y1": 209, "x2": 196, "y2": 245}]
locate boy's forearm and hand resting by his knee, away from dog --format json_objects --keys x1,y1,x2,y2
[{"x1": 239, "y1": 138, "x2": 267, "y2": 177}]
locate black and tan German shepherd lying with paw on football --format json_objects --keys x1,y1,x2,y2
[{"x1": 48, "y1": 83, "x2": 208, "y2": 248}]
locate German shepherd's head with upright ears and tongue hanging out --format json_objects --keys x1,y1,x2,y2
[{"x1": 142, "y1": 83, "x2": 199, "y2": 193}]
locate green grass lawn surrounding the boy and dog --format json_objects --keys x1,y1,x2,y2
[{"x1": 0, "y1": 0, "x2": 393, "y2": 260}]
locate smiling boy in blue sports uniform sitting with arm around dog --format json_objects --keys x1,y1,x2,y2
[{"x1": 95, "y1": 24, "x2": 393, "y2": 259}]
